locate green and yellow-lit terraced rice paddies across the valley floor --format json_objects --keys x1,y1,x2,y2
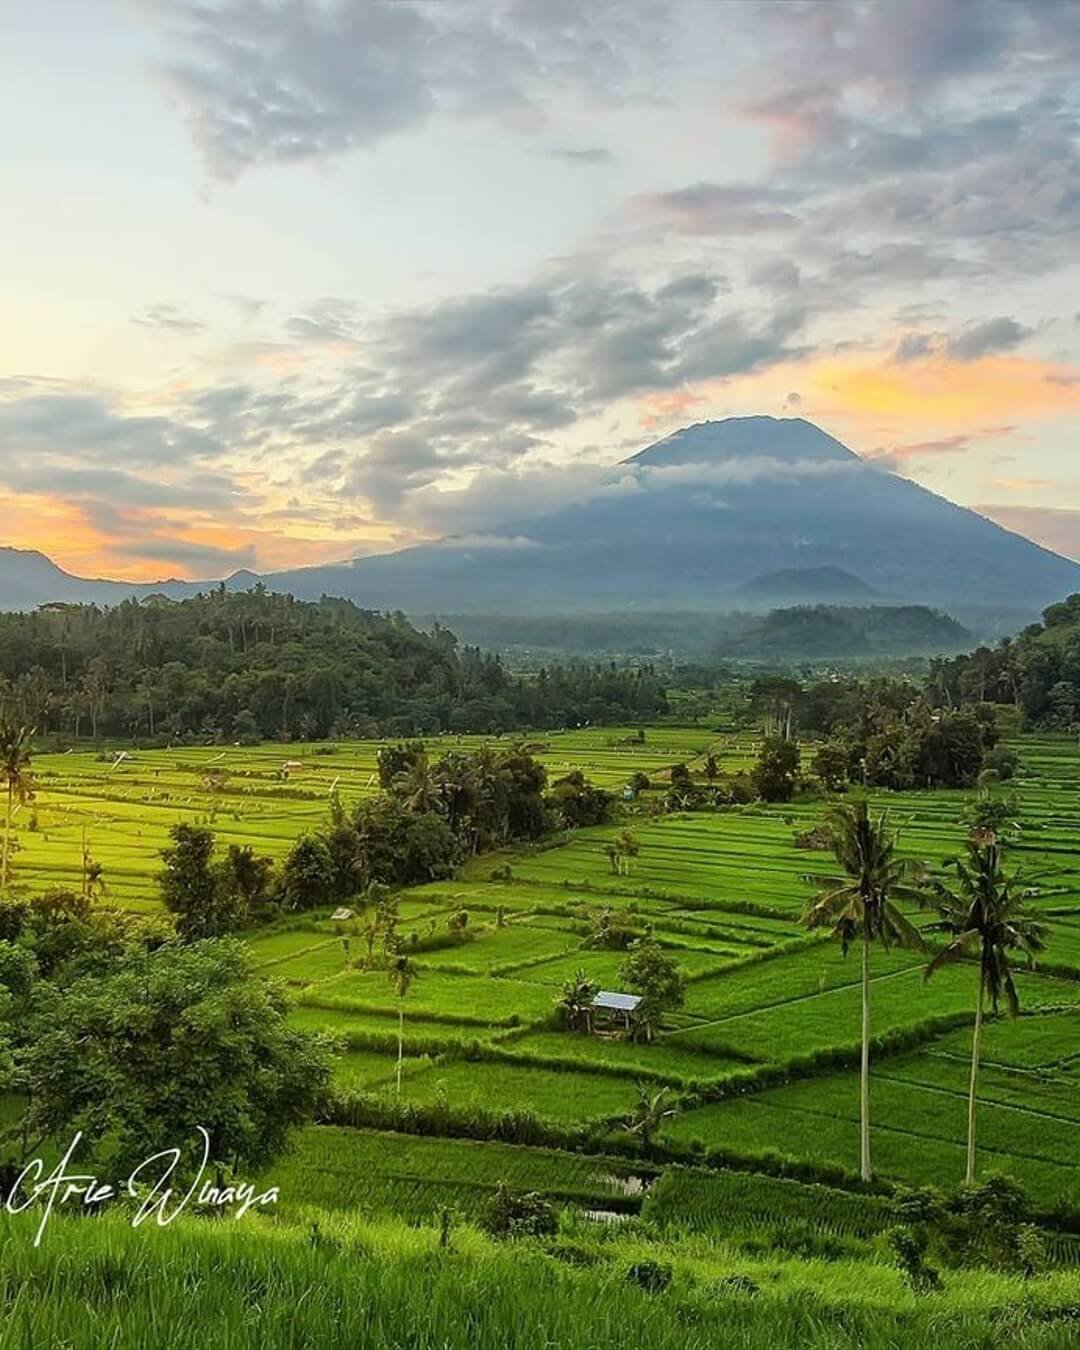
[{"x1": 18, "y1": 728, "x2": 1080, "y2": 1231}]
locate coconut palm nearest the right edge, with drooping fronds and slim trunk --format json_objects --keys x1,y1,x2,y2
[{"x1": 925, "y1": 830, "x2": 1046, "y2": 1184}]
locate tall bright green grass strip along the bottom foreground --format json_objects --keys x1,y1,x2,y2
[{"x1": 0, "y1": 1215, "x2": 1080, "y2": 1350}]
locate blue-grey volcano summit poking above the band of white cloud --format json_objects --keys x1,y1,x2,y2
[{"x1": 625, "y1": 416, "x2": 859, "y2": 464}]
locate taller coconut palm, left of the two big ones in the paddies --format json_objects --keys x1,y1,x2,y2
[{"x1": 803, "y1": 801, "x2": 925, "y2": 1181}]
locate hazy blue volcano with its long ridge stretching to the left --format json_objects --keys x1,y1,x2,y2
[{"x1": 0, "y1": 417, "x2": 1080, "y2": 618}]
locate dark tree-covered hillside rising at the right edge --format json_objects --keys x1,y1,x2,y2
[{"x1": 929, "y1": 595, "x2": 1080, "y2": 730}]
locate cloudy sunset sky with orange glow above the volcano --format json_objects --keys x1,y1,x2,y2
[{"x1": 0, "y1": 0, "x2": 1080, "y2": 579}]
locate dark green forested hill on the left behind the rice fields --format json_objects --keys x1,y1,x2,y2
[{"x1": 0, "y1": 587, "x2": 667, "y2": 741}]
